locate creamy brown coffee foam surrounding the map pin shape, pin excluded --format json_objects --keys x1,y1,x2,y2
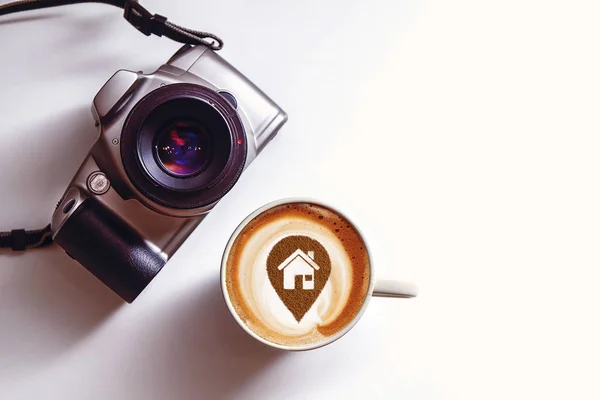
[{"x1": 226, "y1": 203, "x2": 370, "y2": 346}]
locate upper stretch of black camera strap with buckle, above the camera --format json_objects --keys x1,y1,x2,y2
[{"x1": 0, "y1": 0, "x2": 223, "y2": 50}]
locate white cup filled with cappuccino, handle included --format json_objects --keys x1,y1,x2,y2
[{"x1": 221, "y1": 199, "x2": 417, "y2": 350}]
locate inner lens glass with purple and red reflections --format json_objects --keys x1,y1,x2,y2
[{"x1": 155, "y1": 121, "x2": 213, "y2": 177}]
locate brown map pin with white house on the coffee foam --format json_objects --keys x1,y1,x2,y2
[{"x1": 267, "y1": 235, "x2": 331, "y2": 322}]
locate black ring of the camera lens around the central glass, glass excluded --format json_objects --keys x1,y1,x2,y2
[{"x1": 121, "y1": 83, "x2": 247, "y2": 209}]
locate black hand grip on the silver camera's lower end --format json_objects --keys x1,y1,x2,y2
[{"x1": 54, "y1": 198, "x2": 165, "y2": 303}]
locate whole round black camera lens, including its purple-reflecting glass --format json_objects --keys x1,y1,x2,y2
[{"x1": 121, "y1": 83, "x2": 248, "y2": 211}]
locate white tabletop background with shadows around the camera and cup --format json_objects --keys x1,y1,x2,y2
[{"x1": 0, "y1": 0, "x2": 600, "y2": 400}]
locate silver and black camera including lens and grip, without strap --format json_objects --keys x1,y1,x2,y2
[{"x1": 51, "y1": 45, "x2": 287, "y2": 303}]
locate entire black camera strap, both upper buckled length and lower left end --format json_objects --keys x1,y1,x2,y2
[{"x1": 0, "y1": 0, "x2": 223, "y2": 251}]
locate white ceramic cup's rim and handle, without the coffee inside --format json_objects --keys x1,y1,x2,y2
[{"x1": 221, "y1": 197, "x2": 417, "y2": 351}]
